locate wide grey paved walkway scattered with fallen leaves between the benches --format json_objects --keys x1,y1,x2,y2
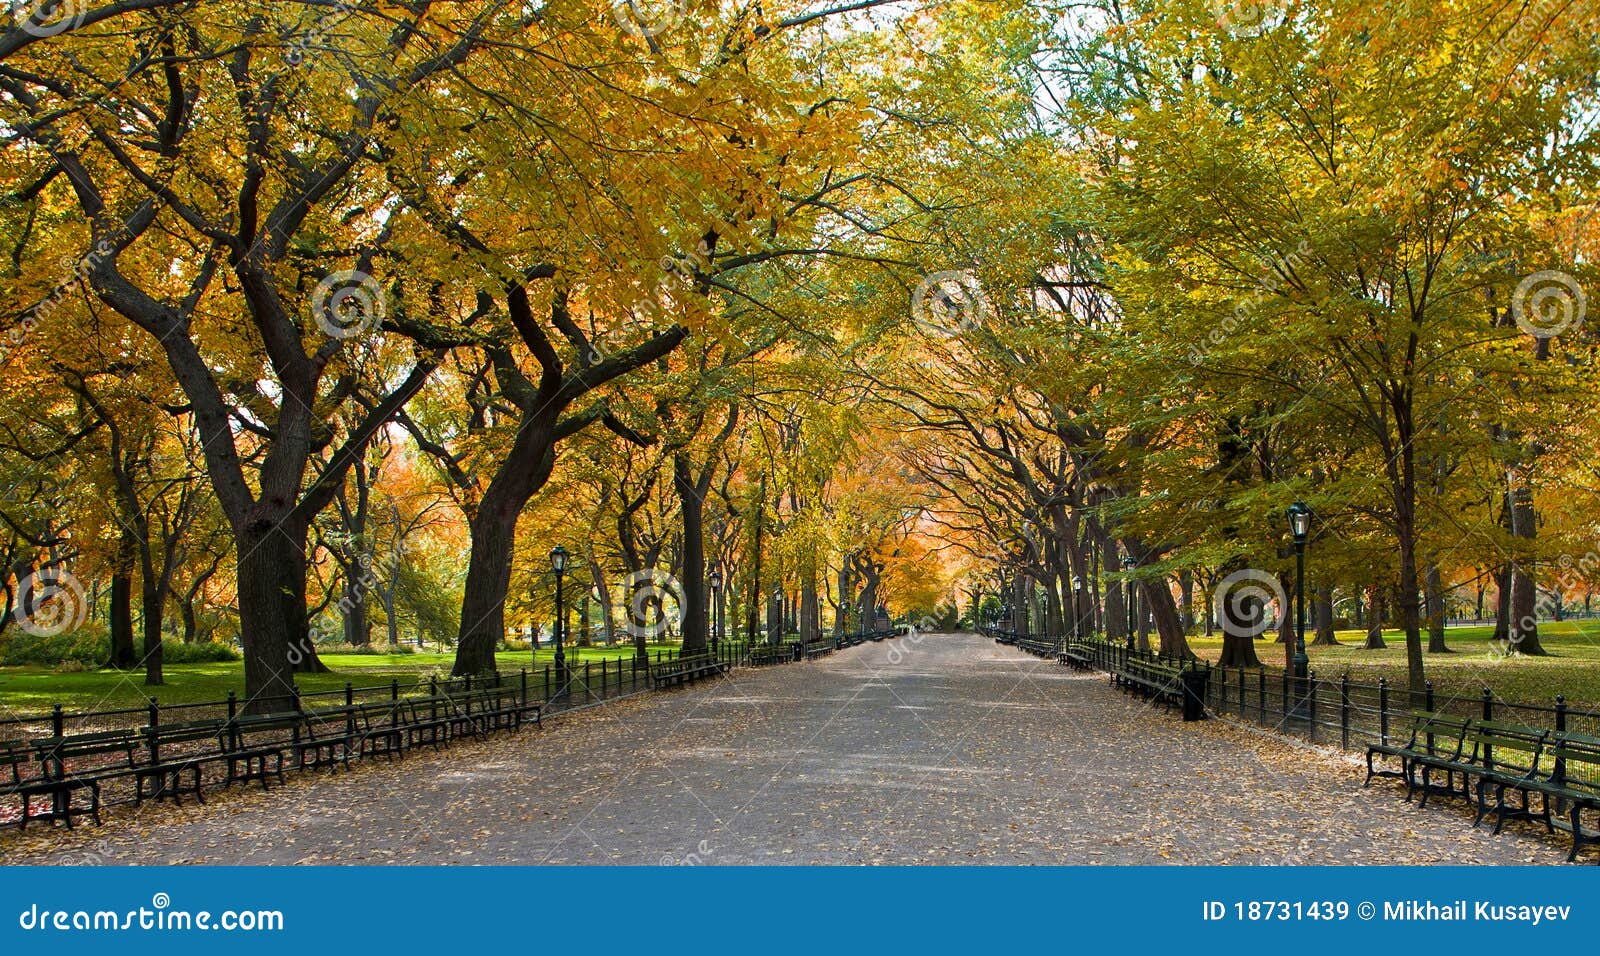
[{"x1": 0, "y1": 635, "x2": 1562, "y2": 865}]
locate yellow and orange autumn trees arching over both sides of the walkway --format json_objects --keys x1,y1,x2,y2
[{"x1": 0, "y1": 0, "x2": 1600, "y2": 722}]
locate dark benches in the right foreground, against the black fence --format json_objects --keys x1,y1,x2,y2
[{"x1": 1366, "y1": 710, "x2": 1600, "y2": 862}]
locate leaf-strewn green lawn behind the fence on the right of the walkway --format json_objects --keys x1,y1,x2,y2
[{"x1": 1189, "y1": 620, "x2": 1600, "y2": 705}]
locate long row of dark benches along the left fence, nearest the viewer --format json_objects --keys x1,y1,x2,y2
[{"x1": 0, "y1": 687, "x2": 542, "y2": 828}]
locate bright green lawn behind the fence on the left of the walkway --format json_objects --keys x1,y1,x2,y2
[{"x1": 0, "y1": 644, "x2": 675, "y2": 718}]
